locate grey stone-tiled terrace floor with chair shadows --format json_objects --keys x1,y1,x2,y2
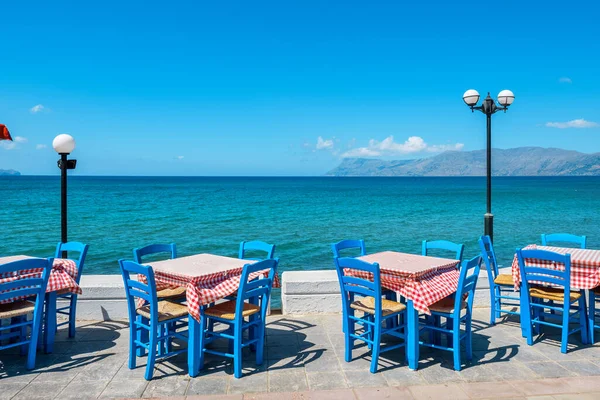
[{"x1": 0, "y1": 309, "x2": 600, "y2": 400}]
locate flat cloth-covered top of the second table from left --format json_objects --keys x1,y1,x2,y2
[{"x1": 148, "y1": 253, "x2": 256, "y2": 278}]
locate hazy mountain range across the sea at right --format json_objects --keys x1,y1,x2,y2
[{"x1": 326, "y1": 147, "x2": 600, "y2": 176}]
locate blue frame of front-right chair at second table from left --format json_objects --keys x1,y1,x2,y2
[{"x1": 200, "y1": 259, "x2": 279, "y2": 378}]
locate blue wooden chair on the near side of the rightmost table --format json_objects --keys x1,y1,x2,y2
[{"x1": 517, "y1": 250, "x2": 587, "y2": 353}]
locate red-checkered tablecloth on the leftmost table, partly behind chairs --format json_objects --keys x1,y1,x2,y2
[{"x1": 0, "y1": 258, "x2": 82, "y2": 303}]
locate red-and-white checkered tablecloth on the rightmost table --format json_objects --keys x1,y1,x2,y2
[{"x1": 512, "y1": 244, "x2": 600, "y2": 290}]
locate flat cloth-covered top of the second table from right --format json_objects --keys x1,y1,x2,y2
[{"x1": 358, "y1": 251, "x2": 459, "y2": 274}]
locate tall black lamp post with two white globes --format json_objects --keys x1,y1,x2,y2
[{"x1": 463, "y1": 89, "x2": 515, "y2": 241}]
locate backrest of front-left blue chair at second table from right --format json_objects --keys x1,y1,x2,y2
[{"x1": 334, "y1": 257, "x2": 381, "y2": 318}]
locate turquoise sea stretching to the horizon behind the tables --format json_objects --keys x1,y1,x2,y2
[{"x1": 0, "y1": 176, "x2": 600, "y2": 304}]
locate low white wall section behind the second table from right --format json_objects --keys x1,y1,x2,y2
[{"x1": 281, "y1": 269, "x2": 510, "y2": 315}]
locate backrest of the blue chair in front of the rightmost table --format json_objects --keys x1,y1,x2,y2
[{"x1": 517, "y1": 249, "x2": 571, "y2": 299}]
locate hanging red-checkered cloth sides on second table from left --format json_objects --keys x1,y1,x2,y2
[{"x1": 154, "y1": 268, "x2": 281, "y2": 321}]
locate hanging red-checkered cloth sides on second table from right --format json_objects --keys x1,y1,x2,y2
[{"x1": 344, "y1": 261, "x2": 460, "y2": 314}]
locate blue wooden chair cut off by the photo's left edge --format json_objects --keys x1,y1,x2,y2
[{"x1": 0, "y1": 258, "x2": 52, "y2": 369}]
